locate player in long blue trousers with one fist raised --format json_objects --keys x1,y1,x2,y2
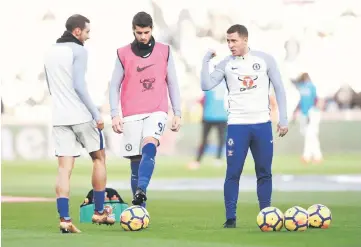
[{"x1": 201, "y1": 25, "x2": 288, "y2": 228}]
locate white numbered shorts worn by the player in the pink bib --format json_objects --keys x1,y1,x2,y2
[{"x1": 121, "y1": 112, "x2": 168, "y2": 157}]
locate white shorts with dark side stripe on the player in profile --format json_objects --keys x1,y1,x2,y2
[{"x1": 53, "y1": 121, "x2": 105, "y2": 157}]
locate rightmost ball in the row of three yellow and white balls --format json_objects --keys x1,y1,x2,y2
[{"x1": 307, "y1": 204, "x2": 332, "y2": 229}]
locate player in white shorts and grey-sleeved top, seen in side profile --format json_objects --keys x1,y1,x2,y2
[{"x1": 44, "y1": 15, "x2": 115, "y2": 233}]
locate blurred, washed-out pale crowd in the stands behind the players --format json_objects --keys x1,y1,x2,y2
[{"x1": 0, "y1": 0, "x2": 361, "y2": 120}]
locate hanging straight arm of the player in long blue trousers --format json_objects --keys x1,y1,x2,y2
[{"x1": 267, "y1": 56, "x2": 288, "y2": 136}]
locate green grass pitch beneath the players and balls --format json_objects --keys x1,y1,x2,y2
[{"x1": 1, "y1": 155, "x2": 361, "y2": 247}]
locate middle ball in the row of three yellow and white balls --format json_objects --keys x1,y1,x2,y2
[{"x1": 284, "y1": 206, "x2": 308, "y2": 231}]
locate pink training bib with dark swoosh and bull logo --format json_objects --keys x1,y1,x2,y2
[{"x1": 118, "y1": 42, "x2": 169, "y2": 117}]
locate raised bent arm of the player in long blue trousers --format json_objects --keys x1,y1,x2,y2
[{"x1": 201, "y1": 51, "x2": 228, "y2": 91}]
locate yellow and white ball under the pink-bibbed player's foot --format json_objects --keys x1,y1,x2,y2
[{"x1": 120, "y1": 206, "x2": 150, "y2": 231}]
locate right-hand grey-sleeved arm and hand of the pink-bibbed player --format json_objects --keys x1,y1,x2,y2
[{"x1": 167, "y1": 50, "x2": 182, "y2": 131}]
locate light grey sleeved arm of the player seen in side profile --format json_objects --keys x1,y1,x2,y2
[{"x1": 73, "y1": 49, "x2": 101, "y2": 122}]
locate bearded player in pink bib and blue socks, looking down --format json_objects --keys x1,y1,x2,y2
[{"x1": 109, "y1": 12, "x2": 181, "y2": 206}]
